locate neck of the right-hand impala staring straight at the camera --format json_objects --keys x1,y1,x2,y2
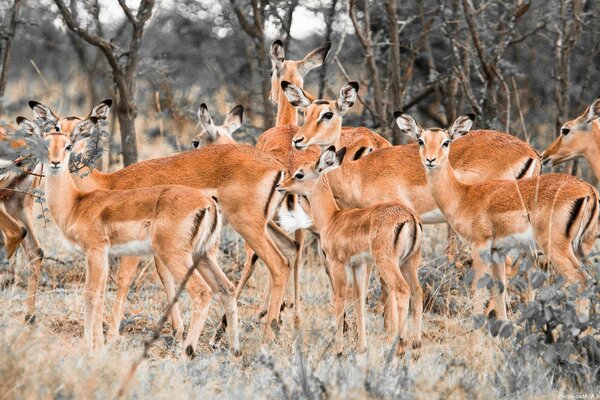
[{"x1": 423, "y1": 159, "x2": 467, "y2": 226}]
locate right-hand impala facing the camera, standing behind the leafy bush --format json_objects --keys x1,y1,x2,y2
[{"x1": 395, "y1": 113, "x2": 599, "y2": 319}]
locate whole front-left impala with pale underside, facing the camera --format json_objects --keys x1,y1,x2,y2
[{"x1": 39, "y1": 117, "x2": 239, "y2": 356}]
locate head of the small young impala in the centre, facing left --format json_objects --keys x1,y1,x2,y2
[{"x1": 277, "y1": 146, "x2": 346, "y2": 196}]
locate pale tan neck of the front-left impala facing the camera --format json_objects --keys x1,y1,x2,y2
[{"x1": 45, "y1": 164, "x2": 79, "y2": 227}]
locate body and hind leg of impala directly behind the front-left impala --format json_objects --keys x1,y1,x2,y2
[{"x1": 29, "y1": 99, "x2": 296, "y2": 339}]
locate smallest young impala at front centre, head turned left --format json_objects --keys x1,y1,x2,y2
[{"x1": 277, "y1": 146, "x2": 423, "y2": 354}]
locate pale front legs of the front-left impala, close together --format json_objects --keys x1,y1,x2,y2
[{"x1": 83, "y1": 248, "x2": 108, "y2": 350}]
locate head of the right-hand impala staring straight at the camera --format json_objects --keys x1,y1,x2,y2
[{"x1": 394, "y1": 112, "x2": 475, "y2": 171}]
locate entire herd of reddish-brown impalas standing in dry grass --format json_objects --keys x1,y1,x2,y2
[{"x1": 0, "y1": 41, "x2": 600, "y2": 356}]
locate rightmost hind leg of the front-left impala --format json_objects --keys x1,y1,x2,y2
[{"x1": 197, "y1": 247, "x2": 241, "y2": 356}]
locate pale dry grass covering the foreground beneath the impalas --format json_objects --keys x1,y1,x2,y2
[{"x1": 0, "y1": 219, "x2": 558, "y2": 398}]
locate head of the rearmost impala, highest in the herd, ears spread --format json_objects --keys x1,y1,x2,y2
[{"x1": 270, "y1": 40, "x2": 331, "y2": 104}]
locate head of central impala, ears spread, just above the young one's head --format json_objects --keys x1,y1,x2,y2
[{"x1": 281, "y1": 81, "x2": 358, "y2": 150}]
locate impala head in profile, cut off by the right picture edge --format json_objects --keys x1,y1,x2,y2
[{"x1": 542, "y1": 98, "x2": 600, "y2": 179}]
